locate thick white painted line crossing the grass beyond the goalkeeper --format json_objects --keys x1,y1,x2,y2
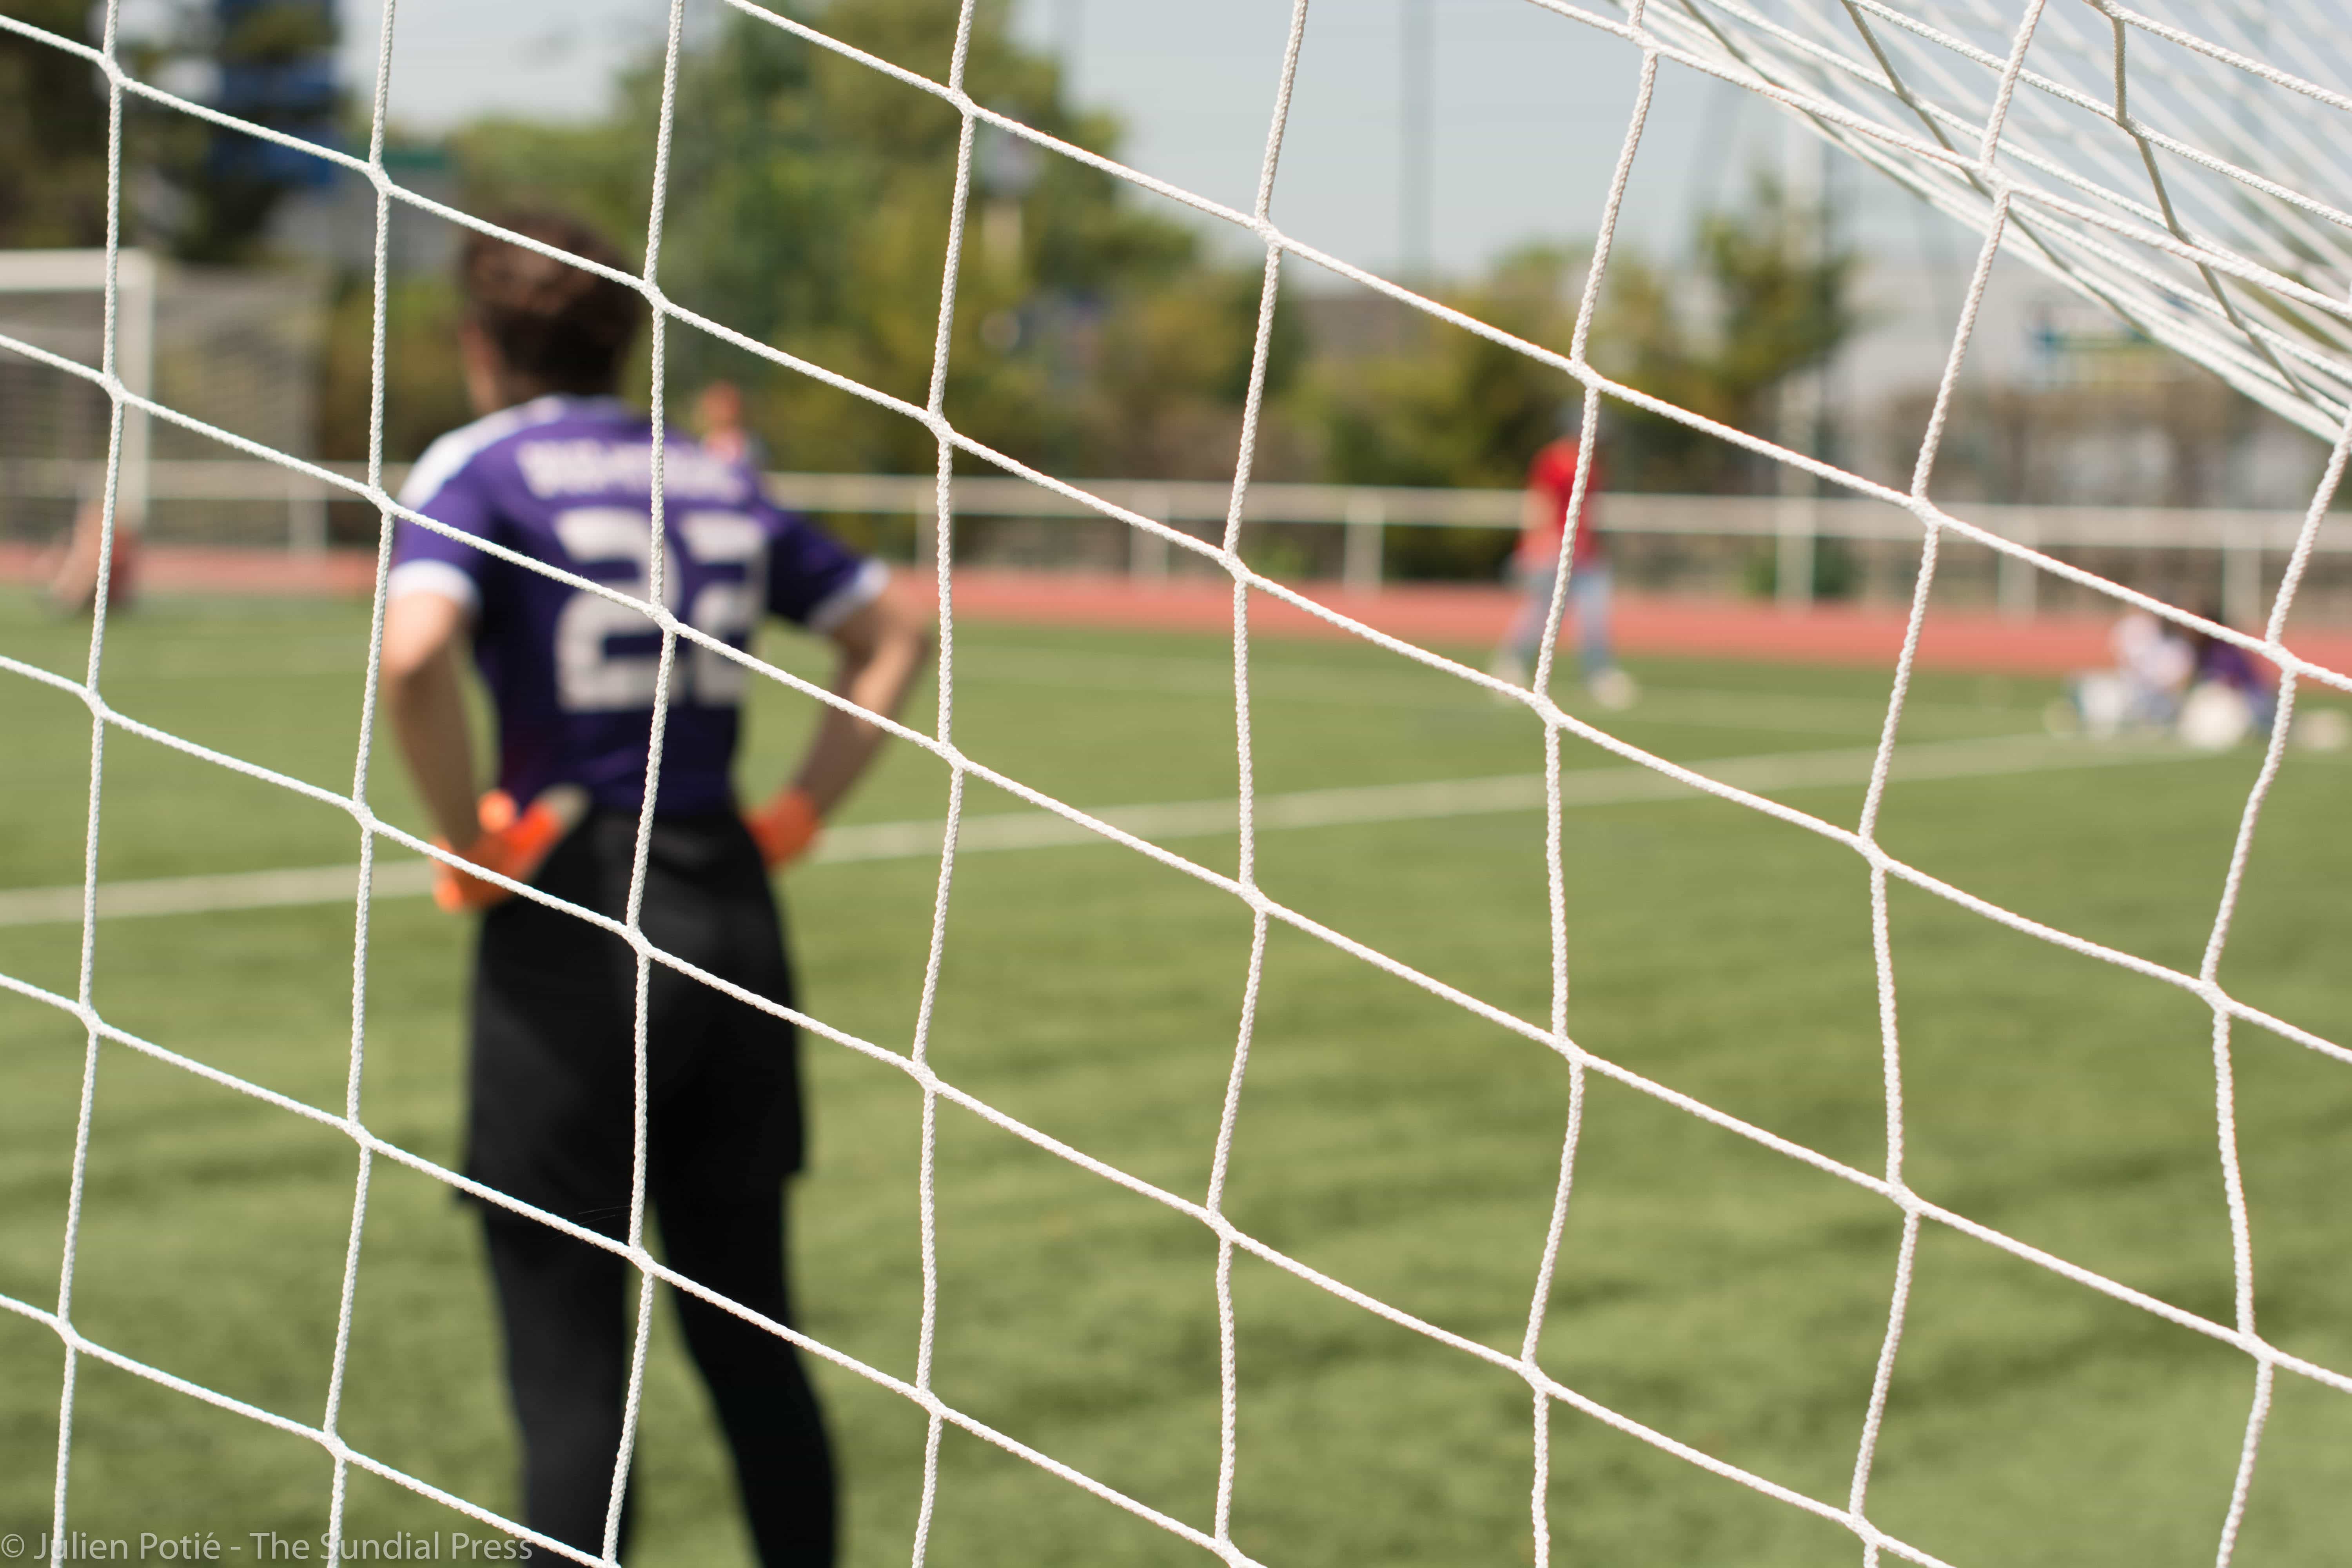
[{"x1": 0, "y1": 736, "x2": 2194, "y2": 926}]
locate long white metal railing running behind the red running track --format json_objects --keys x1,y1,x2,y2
[{"x1": 0, "y1": 458, "x2": 2352, "y2": 625}]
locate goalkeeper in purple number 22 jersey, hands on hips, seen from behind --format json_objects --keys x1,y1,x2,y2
[{"x1": 383, "y1": 216, "x2": 929, "y2": 1568}]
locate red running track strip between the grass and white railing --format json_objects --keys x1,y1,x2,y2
[{"x1": 0, "y1": 545, "x2": 2352, "y2": 675}]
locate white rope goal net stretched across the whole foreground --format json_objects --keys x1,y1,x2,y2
[{"x1": 0, "y1": 0, "x2": 2352, "y2": 1566}]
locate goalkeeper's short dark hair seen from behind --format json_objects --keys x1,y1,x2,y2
[{"x1": 456, "y1": 212, "x2": 644, "y2": 392}]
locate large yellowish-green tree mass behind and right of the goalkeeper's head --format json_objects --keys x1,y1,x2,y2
[{"x1": 428, "y1": 0, "x2": 1270, "y2": 475}]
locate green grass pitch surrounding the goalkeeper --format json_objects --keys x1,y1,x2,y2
[{"x1": 0, "y1": 599, "x2": 2352, "y2": 1568}]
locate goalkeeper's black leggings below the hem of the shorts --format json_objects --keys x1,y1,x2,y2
[{"x1": 485, "y1": 1194, "x2": 835, "y2": 1568}]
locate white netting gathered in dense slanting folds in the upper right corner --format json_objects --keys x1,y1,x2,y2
[{"x1": 1628, "y1": 0, "x2": 2352, "y2": 439}]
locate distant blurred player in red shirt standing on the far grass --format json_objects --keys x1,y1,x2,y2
[{"x1": 1494, "y1": 399, "x2": 1639, "y2": 708}]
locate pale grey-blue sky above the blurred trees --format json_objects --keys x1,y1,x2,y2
[{"x1": 327, "y1": 0, "x2": 1872, "y2": 273}]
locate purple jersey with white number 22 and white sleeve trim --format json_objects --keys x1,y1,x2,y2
[{"x1": 388, "y1": 397, "x2": 884, "y2": 813}]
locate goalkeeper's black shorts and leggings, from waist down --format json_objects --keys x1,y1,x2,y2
[{"x1": 466, "y1": 811, "x2": 835, "y2": 1568}]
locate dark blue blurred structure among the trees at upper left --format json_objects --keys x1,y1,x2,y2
[{"x1": 205, "y1": 0, "x2": 339, "y2": 191}]
